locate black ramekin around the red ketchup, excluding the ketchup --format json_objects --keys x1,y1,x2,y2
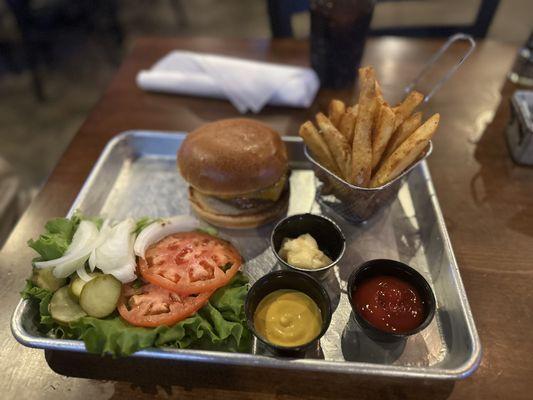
[{"x1": 347, "y1": 259, "x2": 436, "y2": 342}]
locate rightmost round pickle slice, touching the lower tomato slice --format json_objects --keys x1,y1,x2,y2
[{"x1": 80, "y1": 274, "x2": 122, "y2": 318}]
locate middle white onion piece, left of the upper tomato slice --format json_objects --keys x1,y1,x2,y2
[{"x1": 90, "y1": 218, "x2": 136, "y2": 283}]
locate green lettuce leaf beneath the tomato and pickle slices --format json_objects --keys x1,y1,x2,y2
[{"x1": 21, "y1": 272, "x2": 252, "y2": 356}]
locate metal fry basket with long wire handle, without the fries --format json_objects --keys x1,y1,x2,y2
[{"x1": 304, "y1": 33, "x2": 476, "y2": 223}]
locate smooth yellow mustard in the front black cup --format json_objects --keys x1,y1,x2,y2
[{"x1": 254, "y1": 289, "x2": 322, "y2": 347}]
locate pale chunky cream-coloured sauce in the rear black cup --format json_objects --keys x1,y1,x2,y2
[{"x1": 279, "y1": 233, "x2": 332, "y2": 269}]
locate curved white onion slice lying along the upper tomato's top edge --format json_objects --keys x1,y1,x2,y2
[{"x1": 133, "y1": 215, "x2": 200, "y2": 258}]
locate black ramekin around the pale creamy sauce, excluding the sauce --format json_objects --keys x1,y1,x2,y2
[{"x1": 270, "y1": 213, "x2": 346, "y2": 273}]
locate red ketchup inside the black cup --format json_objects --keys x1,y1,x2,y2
[{"x1": 352, "y1": 275, "x2": 426, "y2": 333}]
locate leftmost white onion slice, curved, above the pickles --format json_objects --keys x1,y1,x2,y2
[{"x1": 34, "y1": 221, "x2": 98, "y2": 278}]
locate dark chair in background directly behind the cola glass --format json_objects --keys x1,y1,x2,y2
[{"x1": 267, "y1": 0, "x2": 500, "y2": 38}]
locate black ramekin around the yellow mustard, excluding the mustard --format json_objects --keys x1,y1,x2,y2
[{"x1": 244, "y1": 270, "x2": 332, "y2": 356}]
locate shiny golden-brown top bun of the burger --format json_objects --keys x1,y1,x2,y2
[{"x1": 178, "y1": 118, "x2": 288, "y2": 196}]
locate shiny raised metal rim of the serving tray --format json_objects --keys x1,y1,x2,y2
[{"x1": 11, "y1": 130, "x2": 482, "y2": 380}]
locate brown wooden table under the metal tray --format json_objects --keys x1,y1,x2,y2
[{"x1": 0, "y1": 38, "x2": 533, "y2": 400}]
